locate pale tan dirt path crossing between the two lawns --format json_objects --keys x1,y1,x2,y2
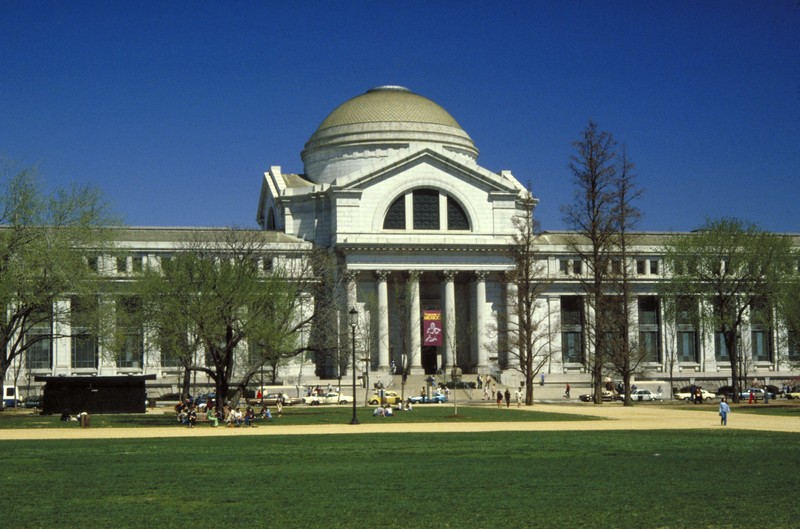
[{"x1": 0, "y1": 404, "x2": 800, "y2": 440}]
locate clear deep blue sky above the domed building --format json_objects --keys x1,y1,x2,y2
[{"x1": 0, "y1": 0, "x2": 800, "y2": 232}]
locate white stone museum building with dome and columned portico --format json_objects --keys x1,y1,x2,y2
[{"x1": 7, "y1": 86, "x2": 797, "y2": 392}]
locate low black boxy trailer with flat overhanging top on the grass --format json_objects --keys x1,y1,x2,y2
[{"x1": 35, "y1": 375, "x2": 156, "y2": 414}]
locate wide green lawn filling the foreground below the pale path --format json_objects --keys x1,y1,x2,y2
[{"x1": 0, "y1": 426, "x2": 800, "y2": 529}]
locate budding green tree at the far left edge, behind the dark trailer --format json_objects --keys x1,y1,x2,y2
[{"x1": 0, "y1": 162, "x2": 117, "y2": 380}]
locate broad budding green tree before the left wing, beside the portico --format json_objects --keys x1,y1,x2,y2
[{"x1": 138, "y1": 229, "x2": 338, "y2": 406}]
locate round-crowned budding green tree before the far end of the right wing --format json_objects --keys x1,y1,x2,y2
[{"x1": 662, "y1": 218, "x2": 796, "y2": 402}]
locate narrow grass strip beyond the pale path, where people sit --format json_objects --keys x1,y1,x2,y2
[{"x1": 0, "y1": 405, "x2": 595, "y2": 429}]
